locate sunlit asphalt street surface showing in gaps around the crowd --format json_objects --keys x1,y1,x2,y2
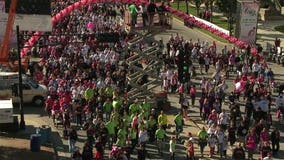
[{"x1": 6, "y1": 16, "x2": 284, "y2": 160}]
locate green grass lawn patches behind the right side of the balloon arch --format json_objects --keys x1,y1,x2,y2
[{"x1": 172, "y1": 1, "x2": 228, "y2": 43}]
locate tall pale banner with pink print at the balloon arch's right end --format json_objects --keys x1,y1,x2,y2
[{"x1": 239, "y1": 1, "x2": 259, "y2": 46}]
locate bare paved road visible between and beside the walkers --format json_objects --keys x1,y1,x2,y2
[{"x1": 12, "y1": 17, "x2": 284, "y2": 160}]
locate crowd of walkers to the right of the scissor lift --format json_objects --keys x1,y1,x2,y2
[{"x1": 160, "y1": 33, "x2": 284, "y2": 159}]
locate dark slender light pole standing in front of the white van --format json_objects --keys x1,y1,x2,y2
[{"x1": 16, "y1": 25, "x2": 26, "y2": 130}]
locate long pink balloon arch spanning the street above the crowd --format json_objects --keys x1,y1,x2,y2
[{"x1": 21, "y1": 0, "x2": 257, "y2": 56}]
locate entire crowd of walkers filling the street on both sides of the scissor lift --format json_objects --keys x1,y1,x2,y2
[{"x1": 13, "y1": 0, "x2": 284, "y2": 160}]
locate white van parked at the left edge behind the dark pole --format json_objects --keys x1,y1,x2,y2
[{"x1": 0, "y1": 72, "x2": 47, "y2": 106}]
